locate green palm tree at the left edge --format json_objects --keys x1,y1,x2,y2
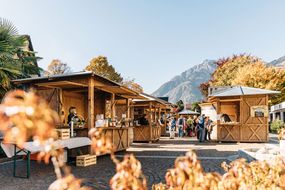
[{"x1": 0, "y1": 18, "x2": 41, "y2": 97}]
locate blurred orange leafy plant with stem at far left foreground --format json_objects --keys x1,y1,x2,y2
[{"x1": 0, "y1": 90, "x2": 86, "y2": 190}]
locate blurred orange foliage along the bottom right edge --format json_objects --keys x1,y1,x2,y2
[{"x1": 152, "y1": 151, "x2": 285, "y2": 190}]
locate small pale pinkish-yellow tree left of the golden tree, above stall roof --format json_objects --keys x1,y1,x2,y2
[{"x1": 46, "y1": 59, "x2": 71, "y2": 75}]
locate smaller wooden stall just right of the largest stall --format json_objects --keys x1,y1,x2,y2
[{"x1": 132, "y1": 94, "x2": 171, "y2": 142}]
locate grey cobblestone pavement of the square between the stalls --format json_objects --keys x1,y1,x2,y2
[{"x1": 0, "y1": 137, "x2": 276, "y2": 190}]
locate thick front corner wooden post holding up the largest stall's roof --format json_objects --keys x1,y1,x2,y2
[{"x1": 88, "y1": 77, "x2": 95, "y2": 130}]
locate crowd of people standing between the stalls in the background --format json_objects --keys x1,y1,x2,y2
[{"x1": 168, "y1": 114, "x2": 213, "y2": 142}]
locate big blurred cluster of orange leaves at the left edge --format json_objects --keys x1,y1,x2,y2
[{"x1": 0, "y1": 90, "x2": 59, "y2": 147}]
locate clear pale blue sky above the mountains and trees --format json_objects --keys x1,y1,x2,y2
[{"x1": 0, "y1": 0, "x2": 285, "y2": 93}]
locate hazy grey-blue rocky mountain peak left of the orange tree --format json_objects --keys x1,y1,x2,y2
[{"x1": 152, "y1": 60, "x2": 216, "y2": 103}]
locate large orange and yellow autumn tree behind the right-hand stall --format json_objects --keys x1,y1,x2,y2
[{"x1": 200, "y1": 54, "x2": 285, "y2": 104}]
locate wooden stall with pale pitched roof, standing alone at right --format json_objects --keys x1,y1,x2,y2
[{"x1": 209, "y1": 86, "x2": 279, "y2": 142}]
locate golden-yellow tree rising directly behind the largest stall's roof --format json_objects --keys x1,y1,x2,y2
[{"x1": 85, "y1": 56, "x2": 123, "y2": 83}]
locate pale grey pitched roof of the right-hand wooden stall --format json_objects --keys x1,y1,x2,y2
[{"x1": 209, "y1": 86, "x2": 280, "y2": 97}]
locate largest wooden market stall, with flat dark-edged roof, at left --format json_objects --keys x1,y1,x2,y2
[{"x1": 14, "y1": 72, "x2": 141, "y2": 156}]
